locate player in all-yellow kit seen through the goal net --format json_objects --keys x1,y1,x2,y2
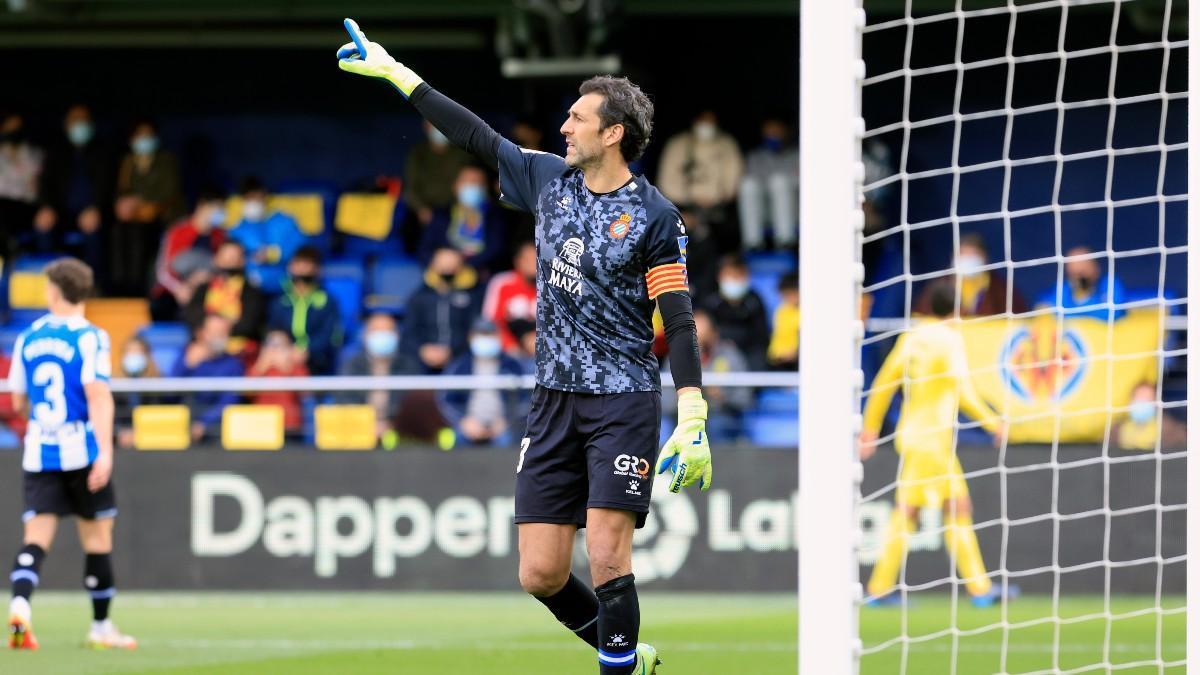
[{"x1": 859, "y1": 285, "x2": 1015, "y2": 607}]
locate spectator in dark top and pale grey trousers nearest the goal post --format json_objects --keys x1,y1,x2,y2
[{"x1": 738, "y1": 118, "x2": 800, "y2": 249}]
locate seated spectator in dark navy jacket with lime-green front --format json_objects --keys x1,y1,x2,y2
[{"x1": 268, "y1": 246, "x2": 343, "y2": 375}]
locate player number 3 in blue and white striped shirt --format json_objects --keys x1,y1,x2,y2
[{"x1": 8, "y1": 258, "x2": 137, "y2": 650}]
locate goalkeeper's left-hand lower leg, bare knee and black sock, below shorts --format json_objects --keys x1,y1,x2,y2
[{"x1": 517, "y1": 522, "x2": 599, "y2": 649}]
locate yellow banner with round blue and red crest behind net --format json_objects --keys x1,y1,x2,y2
[{"x1": 962, "y1": 309, "x2": 1162, "y2": 443}]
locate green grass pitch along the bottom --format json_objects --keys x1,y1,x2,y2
[{"x1": 0, "y1": 592, "x2": 1186, "y2": 675}]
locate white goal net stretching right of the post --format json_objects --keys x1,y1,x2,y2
[{"x1": 854, "y1": 0, "x2": 1188, "y2": 674}]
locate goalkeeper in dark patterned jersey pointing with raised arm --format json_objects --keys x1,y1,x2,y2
[{"x1": 338, "y1": 20, "x2": 712, "y2": 675}]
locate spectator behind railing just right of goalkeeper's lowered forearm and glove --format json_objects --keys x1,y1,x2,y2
[{"x1": 662, "y1": 310, "x2": 754, "y2": 442}]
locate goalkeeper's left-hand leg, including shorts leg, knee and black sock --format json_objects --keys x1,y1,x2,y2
[{"x1": 515, "y1": 387, "x2": 598, "y2": 649}]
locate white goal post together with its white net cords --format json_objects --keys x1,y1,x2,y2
[{"x1": 797, "y1": 0, "x2": 1200, "y2": 675}]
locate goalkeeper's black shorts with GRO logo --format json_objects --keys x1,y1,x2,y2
[{"x1": 515, "y1": 386, "x2": 662, "y2": 527}]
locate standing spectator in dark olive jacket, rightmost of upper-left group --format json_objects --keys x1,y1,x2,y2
[{"x1": 109, "y1": 121, "x2": 184, "y2": 297}]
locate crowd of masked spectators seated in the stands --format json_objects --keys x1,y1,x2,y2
[{"x1": 0, "y1": 104, "x2": 1161, "y2": 444}]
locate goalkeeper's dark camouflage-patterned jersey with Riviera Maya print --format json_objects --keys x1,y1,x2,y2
[{"x1": 497, "y1": 141, "x2": 688, "y2": 394}]
